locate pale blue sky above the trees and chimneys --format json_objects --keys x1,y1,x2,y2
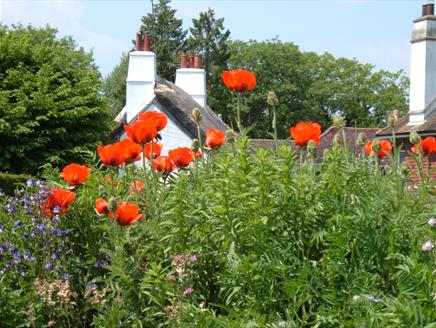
[{"x1": 0, "y1": 0, "x2": 429, "y2": 76}]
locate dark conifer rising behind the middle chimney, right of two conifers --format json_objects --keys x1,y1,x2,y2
[{"x1": 188, "y1": 8, "x2": 231, "y2": 118}]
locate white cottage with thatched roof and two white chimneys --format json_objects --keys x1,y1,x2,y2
[{"x1": 115, "y1": 33, "x2": 229, "y2": 154}]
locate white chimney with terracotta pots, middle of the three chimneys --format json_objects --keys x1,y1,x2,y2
[{"x1": 175, "y1": 53, "x2": 206, "y2": 107}]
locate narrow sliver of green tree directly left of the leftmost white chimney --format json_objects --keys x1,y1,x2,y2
[{"x1": 103, "y1": 53, "x2": 129, "y2": 117}]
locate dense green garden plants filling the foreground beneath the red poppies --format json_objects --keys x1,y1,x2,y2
[{"x1": 0, "y1": 129, "x2": 436, "y2": 327}]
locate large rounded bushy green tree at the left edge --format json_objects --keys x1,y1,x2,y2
[{"x1": 0, "y1": 26, "x2": 111, "y2": 174}]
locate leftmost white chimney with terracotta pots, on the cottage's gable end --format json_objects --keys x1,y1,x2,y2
[{"x1": 123, "y1": 33, "x2": 156, "y2": 122}]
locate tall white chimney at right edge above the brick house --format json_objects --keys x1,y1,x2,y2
[{"x1": 409, "y1": 4, "x2": 436, "y2": 125}]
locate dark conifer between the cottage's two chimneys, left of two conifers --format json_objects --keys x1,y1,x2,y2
[{"x1": 140, "y1": 0, "x2": 186, "y2": 81}]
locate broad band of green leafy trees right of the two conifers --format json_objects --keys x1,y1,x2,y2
[{"x1": 227, "y1": 39, "x2": 408, "y2": 138}]
